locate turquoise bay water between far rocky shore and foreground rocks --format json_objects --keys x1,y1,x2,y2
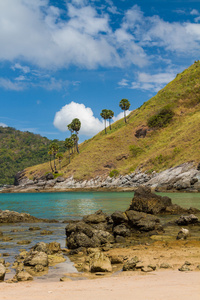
[{"x1": 0, "y1": 192, "x2": 200, "y2": 221}]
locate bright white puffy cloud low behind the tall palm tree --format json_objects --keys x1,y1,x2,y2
[{"x1": 53, "y1": 101, "x2": 104, "y2": 136}]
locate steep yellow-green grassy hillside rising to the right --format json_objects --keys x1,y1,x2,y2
[{"x1": 27, "y1": 61, "x2": 200, "y2": 179}]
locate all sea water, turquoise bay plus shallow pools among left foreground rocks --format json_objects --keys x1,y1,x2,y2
[{"x1": 0, "y1": 192, "x2": 200, "y2": 281}]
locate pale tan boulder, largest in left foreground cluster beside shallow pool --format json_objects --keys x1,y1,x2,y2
[{"x1": 24, "y1": 251, "x2": 48, "y2": 267}]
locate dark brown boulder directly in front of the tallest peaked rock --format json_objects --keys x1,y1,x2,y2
[{"x1": 126, "y1": 210, "x2": 162, "y2": 231}]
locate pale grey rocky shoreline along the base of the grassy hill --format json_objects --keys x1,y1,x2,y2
[{"x1": 2, "y1": 162, "x2": 200, "y2": 192}]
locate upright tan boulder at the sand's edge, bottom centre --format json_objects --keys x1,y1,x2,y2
[{"x1": 90, "y1": 252, "x2": 112, "y2": 273}]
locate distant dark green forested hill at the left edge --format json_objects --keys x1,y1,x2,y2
[{"x1": 0, "y1": 127, "x2": 63, "y2": 185}]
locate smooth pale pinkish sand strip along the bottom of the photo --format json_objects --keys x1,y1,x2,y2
[{"x1": 0, "y1": 270, "x2": 200, "y2": 300}]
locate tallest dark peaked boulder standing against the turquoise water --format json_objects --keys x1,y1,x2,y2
[{"x1": 129, "y1": 186, "x2": 172, "y2": 214}]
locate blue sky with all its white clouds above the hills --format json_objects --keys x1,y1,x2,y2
[{"x1": 0, "y1": 0, "x2": 200, "y2": 141}]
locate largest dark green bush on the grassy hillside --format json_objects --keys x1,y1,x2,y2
[{"x1": 147, "y1": 106, "x2": 174, "y2": 128}]
